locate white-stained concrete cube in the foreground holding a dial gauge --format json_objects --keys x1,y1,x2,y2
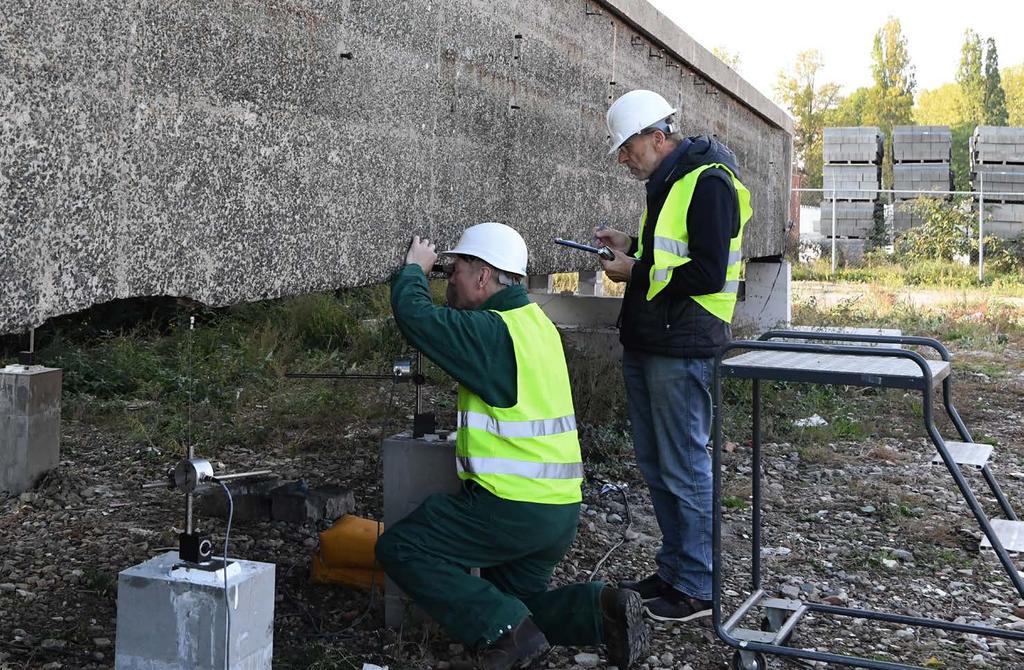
[{"x1": 114, "y1": 551, "x2": 274, "y2": 670}]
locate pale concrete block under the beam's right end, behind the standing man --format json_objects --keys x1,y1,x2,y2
[{"x1": 732, "y1": 260, "x2": 793, "y2": 332}]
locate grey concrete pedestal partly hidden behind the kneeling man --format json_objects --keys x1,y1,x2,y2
[{"x1": 382, "y1": 435, "x2": 462, "y2": 628}]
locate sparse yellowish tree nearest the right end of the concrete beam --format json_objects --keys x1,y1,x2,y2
[{"x1": 775, "y1": 49, "x2": 839, "y2": 201}]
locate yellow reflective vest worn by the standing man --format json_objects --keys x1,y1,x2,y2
[{"x1": 636, "y1": 163, "x2": 754, "y2": 324}]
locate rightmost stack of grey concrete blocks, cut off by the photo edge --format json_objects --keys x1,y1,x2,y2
[{"x1": 971, "y1": 126, "x2": 1024, "y2": 240}]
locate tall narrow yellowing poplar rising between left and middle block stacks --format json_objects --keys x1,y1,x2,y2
[{"x1": 871, "y1": 16, "x2": 916, "y2": 189}]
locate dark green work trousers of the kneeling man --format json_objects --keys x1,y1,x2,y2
[{"x1": 377, "y1": 481, "x2": 604, "y2": 646}]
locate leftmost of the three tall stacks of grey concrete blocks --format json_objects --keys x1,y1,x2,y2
[{"x1": 816, "y1": 126, "x2": 883, "y2": 255}]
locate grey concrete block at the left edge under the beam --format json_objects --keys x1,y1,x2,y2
[{"x1": 0, "y1": 365, "x2": 62, "y2": 494}]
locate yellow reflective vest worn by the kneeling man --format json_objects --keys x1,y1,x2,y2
[{"x1": 456, "y1": 303, "x2": 583, "y2": 505}]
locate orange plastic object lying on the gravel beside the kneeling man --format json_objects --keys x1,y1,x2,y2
[{"x1": 309, "y1": 514, "x2": 384, "y2": 589}]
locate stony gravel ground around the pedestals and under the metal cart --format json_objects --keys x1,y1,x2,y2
[{"x1": 0, "y1": 347, "x2": 1024, "y2": 670}]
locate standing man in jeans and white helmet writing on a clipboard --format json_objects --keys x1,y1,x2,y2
[{"x1": 594, "y1": 90, "x2": 752, "y2": 621}]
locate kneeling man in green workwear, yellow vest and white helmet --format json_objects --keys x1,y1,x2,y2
[{"x1": 377, "y1": 223, "x2": 647, "y2": 670}]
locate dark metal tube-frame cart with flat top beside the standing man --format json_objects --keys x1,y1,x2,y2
[{"x1": 712, "y1": 331, "x2": 1024, "y2": 670}]
